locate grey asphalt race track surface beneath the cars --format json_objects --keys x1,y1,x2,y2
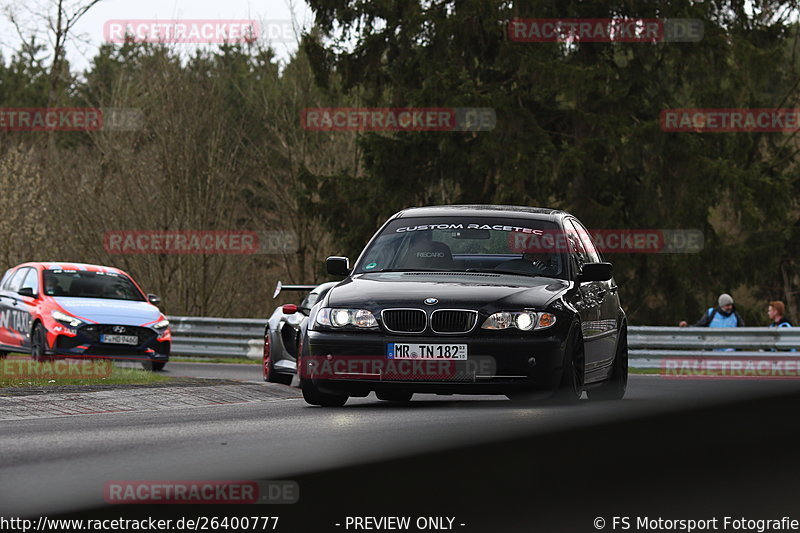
[{"x1": 0, "y1": 363, "x2": 800, "y2": 516}]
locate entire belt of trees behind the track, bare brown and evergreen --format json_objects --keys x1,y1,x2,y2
[{"x1": 0, "y1": 0, "x2": 800, "y2": 324}]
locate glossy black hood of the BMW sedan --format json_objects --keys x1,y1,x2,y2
[{"x1": 327, "y1": 272, "x2": 571, "y2": 309}]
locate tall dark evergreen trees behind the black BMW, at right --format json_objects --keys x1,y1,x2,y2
[{"x1": 309, "y1": 0, "x2": 798, "y2": 324}]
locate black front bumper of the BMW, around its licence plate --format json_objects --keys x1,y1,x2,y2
[{"x1": 299, "y1": 330, "x2": 566, "y2": 396}]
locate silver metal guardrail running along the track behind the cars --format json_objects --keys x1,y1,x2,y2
[{"x1": 169, "y1": 316, "x2": 800, "y2": 369}]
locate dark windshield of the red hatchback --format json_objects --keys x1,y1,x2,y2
[{"x1": 44, "y1": 270, "x2": 145, "y2": 302}]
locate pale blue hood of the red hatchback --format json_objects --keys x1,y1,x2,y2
[{"x1": 53, "y1": 296, "x2": 161, "y2": 326}]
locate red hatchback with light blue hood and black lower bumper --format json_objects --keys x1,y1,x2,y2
[{"x1": 0, "y1": 263, "x2": 172, "y2": 370}]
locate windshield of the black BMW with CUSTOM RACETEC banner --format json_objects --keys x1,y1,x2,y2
[{"x1": 355, "y1": 216, "x2": 568, "y2": 279}]
